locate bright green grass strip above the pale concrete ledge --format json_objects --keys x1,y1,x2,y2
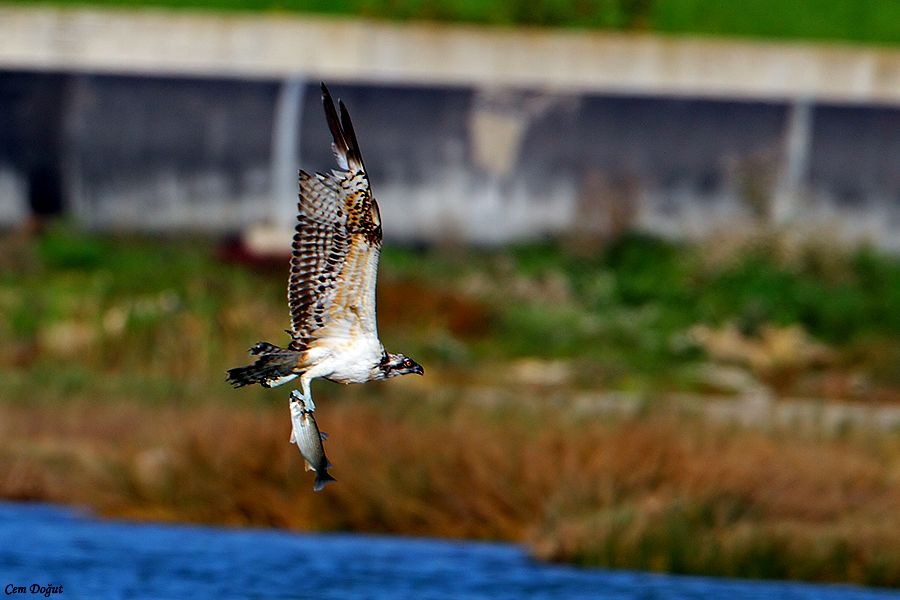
[{"x1": 3, "y1": 0, "x2": 900, "y2": 44}]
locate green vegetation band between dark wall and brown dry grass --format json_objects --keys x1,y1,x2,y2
[{"x1": 0, "y1": 227, "x2": 900, "y2": 403}]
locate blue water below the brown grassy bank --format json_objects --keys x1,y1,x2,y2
[{"x1": 0, "y1": 503, "x2": 900, "y2": 600}]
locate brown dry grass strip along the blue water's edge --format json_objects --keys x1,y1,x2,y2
[{"x1": 0, "y1": 396, "x2": 900, "y2": 586}]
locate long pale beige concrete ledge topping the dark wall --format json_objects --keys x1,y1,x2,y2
[{"x1": 0, "y1": 6, "x2": 900, "y2": 105}]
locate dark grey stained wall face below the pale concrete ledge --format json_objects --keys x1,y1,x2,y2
[{"x1": 0, "y1": 7, "x2": 900, "y2": 249}]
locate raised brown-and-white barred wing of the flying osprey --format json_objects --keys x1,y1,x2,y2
[{"x1": 288, "y1": 83, "x2": 381, "y2": 350}]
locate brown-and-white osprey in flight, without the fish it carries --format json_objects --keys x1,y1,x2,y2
[{"x1": 228, "y1": 83, "x2": 424, "y2": 406}]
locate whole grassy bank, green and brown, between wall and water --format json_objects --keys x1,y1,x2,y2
[{"x1": 0, "y1": 228, "x2": 900, "y2": 586}]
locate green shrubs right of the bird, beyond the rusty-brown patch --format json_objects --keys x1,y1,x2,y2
[{"x1": 385, "y1": 234, "x2": 900, "y2": 389}]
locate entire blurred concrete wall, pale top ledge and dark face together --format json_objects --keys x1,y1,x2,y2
[{"x1": 0, "y1": 8, "x2": 900, "y2": 250}]
